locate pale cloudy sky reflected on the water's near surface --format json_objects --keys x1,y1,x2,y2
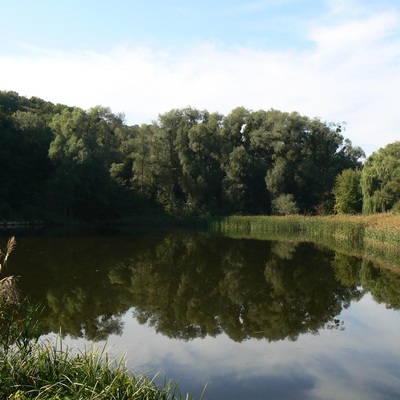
[{"x1": 58, "y1": 294, "x2": 400, "y2": 400}]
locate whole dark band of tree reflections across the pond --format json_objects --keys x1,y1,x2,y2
[{"x1": 11, "y1": 233, "x2": 400, "y2": 341}]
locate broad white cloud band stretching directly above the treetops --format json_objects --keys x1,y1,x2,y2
[{"x1": 0, "y1": 7, "x2": 400, "y2": 154}]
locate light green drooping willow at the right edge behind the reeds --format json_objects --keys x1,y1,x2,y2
[{"x1": 361, "y1": 141, "x2": 400, "y2": 214}]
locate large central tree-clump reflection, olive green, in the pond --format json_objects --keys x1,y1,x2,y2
[{"x1": 108, "y1": 237, "x2": 359, "y2": 341}]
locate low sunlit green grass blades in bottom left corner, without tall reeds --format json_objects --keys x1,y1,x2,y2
[{"x1": 0, "y1": 342, "x2": 198, "y2": 400}]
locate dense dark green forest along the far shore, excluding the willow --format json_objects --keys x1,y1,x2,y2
[{"x1": 0, "y1": 92, "x2": 364, "y2": 220}]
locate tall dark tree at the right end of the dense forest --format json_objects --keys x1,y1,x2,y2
[{"x1": 266, "y1": 110, "x2": 362, "y2": 213}]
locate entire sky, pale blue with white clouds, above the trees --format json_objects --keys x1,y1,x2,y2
[{"x1": 0, "y1": 0, "x2": 400, "y2": 155}]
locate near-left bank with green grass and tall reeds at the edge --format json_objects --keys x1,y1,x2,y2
[{"x1": 0, "y1": 304, "x2": 199, "y2": 400}]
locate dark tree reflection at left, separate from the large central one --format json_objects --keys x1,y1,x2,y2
[{"x1": 13, "y1": 238, "x2": 159, "y2": 340}]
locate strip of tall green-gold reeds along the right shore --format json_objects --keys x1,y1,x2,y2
[{"x1": 212, "y1": 214, "x2": 400, "y2": 271}]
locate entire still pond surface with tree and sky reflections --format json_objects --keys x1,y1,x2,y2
[{"x1": 2, "y1": 232, "x2": 400, "y2": 400}]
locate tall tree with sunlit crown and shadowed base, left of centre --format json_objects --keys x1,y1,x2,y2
[{"x1": 49, "y1": 107, "x2": 122, "y2": 218}]
